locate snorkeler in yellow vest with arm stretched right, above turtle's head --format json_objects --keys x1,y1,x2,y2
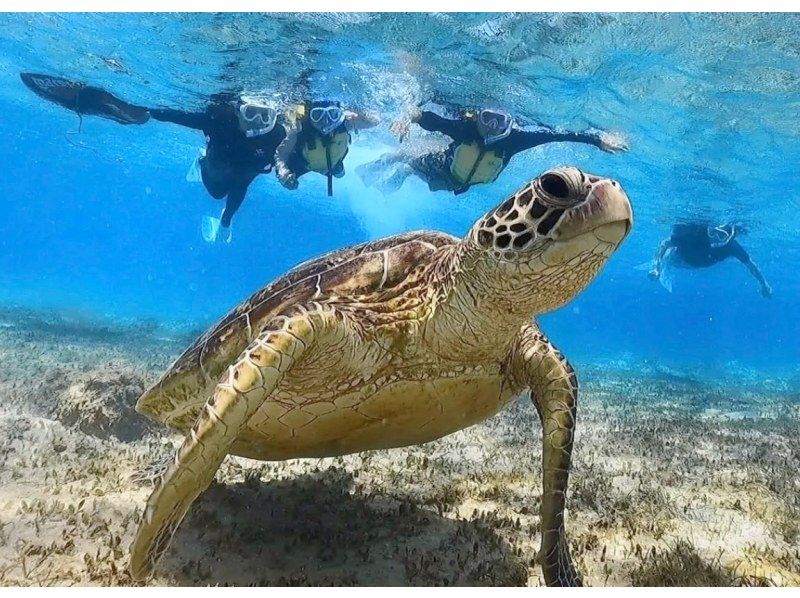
[{"x1": 358, "y1": 108, "x2": 628, "y2": 195}]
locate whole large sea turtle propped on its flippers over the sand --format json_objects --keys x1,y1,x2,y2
[{"x1": 131, "y1": 167, "x2": 633, "y2": 585}]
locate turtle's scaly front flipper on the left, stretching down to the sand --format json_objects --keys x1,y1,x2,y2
[{"x1": 130, "y1": 310, "x2": 325, "y2": 579}]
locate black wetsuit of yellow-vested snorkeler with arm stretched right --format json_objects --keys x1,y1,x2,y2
[{"x1": 410, "y1": 111, "x2": 600, "y2": 195}]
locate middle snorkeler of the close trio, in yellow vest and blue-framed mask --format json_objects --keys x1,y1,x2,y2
[{"x1": 275, "y1": 101, "x2": 380, "y2": 196}]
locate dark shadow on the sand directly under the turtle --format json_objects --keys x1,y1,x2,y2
[{"x1": 158, "y1": 468, "x2": 528, "y2": 586}]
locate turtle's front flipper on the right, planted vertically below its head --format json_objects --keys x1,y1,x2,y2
[{"x1": 511, "y1": 326, "x2": 583, "y2": 586}]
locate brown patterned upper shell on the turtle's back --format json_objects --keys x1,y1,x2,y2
[{"x1": 136, "y1": 231, "x2": 460, "y2": 424}]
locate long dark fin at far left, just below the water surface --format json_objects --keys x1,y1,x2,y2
[{"x1": 19, "y1": 73, "x2": 150, "y2": 125}]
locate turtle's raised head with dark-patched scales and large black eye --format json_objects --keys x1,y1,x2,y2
[{"x1": 465, "y1": 166, "x2": 633, "y2": 315}]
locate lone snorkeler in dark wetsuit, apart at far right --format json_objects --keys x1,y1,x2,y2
[{"x1": 648, "y1": 223, "x2": 772, "y2": 298}]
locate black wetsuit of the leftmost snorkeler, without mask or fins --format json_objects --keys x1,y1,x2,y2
[{"x1": 149, "y1": 104, "x2": 286, "y2": 227}]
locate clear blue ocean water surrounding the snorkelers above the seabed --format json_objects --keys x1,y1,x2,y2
[{"x1": 0, "y1": 14, "x2": 800, "y2": 375}]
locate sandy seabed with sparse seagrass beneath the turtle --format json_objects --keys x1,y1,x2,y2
[{"x1": 0, "y1": 309, "x2": 800, "y2": 586}]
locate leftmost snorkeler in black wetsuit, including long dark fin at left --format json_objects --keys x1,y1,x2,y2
[{"x1": 20, "y1": 73, "x2": 286, "y2": 242}]
